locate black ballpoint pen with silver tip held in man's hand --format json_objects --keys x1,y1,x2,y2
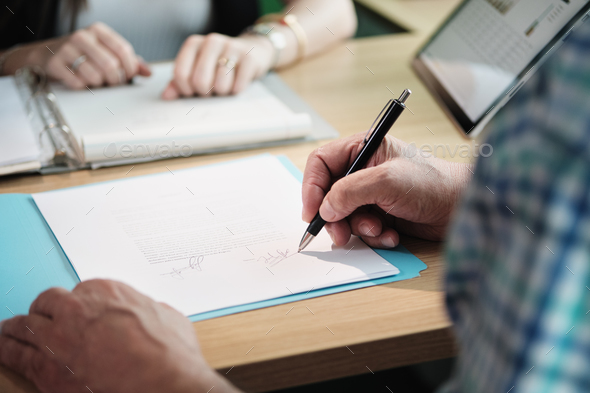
[{"x1": 297, "y1": 89, "x2": 412, "y2": 252}]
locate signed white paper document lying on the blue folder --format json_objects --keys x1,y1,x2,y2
[{"x1": 33, "y1": 155, "x2": 399, "y2": 316}]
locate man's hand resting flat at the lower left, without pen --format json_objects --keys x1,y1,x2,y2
[{"x1": 0, "y1": 280, "x2": 237, "y2": 393}]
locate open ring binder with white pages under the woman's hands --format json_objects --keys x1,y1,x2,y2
[{"x1": 0, "y1": 62, "x2": 338, "y2": 176}]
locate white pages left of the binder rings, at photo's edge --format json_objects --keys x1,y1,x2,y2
[{"x1": 0, "y1": 76, "x2": 40, "y2": 168}]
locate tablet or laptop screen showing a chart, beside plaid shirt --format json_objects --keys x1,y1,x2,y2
[{"x1": 412, "y1": 0, "x2": 590, "y2": 138}]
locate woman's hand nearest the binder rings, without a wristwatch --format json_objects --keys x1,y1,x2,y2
[{"x1": 5, "y1": 23, "x2": 151, "y2": 90}]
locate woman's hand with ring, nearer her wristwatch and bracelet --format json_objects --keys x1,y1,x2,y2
[{"x1": 162, "y1": 33, "x2": 274, "y2": 100}]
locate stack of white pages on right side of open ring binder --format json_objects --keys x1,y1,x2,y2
[{"x1": 52, "y1": 63, "x2": 312, "y2": 162}]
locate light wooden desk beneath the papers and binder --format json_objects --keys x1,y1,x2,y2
[{"x1": 0, "y1": 22, "x2": 464, "y2": 392}]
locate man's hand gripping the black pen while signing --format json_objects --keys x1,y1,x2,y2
[{"x1": 302, "y1": 133, "x2": 471, "y2": 248}]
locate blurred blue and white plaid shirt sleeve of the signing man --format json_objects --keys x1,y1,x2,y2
[{"x1": 441, "y1": 19, "x2": 590, "y2": 393}]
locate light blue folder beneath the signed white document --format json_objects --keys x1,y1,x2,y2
[{"x1": 0, "y1": 156, "x2": 427, "y2": 322}]
